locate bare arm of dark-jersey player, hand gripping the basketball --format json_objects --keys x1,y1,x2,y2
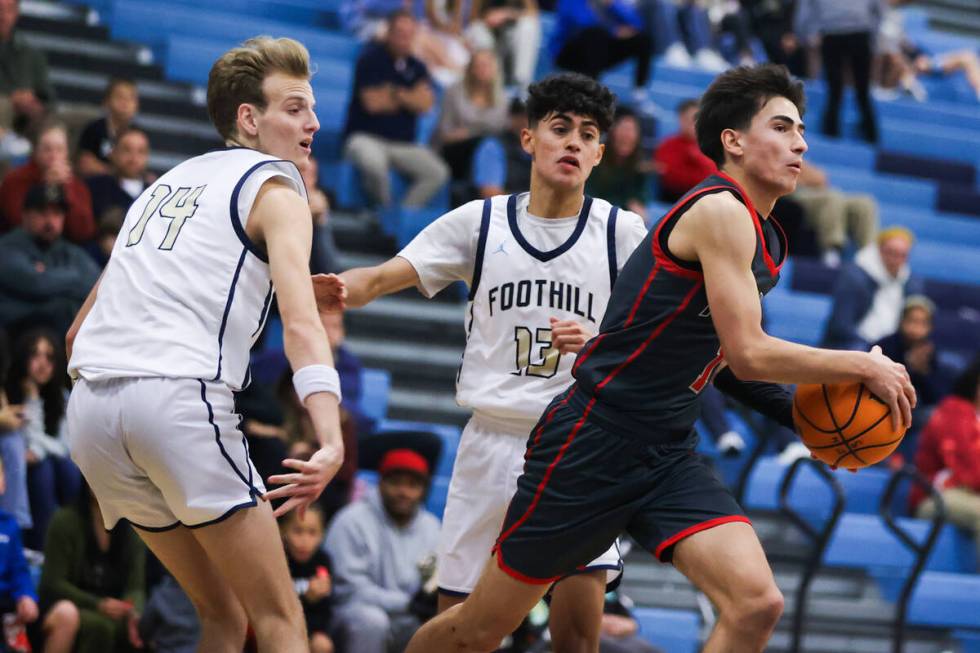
[{"x1": 669, "y1": 193, "x2": 915, "y2": 429}]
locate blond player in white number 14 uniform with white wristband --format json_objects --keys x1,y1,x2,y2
[{"x1": 67, "y1": 37, "x2": 343, "y2": 653}]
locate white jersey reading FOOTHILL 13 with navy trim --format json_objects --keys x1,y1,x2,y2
[{"x1": 399, "y1": 193, "x2": 647, "y2": 434}]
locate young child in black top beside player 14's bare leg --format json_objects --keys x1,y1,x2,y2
[{"x1": 279, "y1": 504, "x2": 334, "y2": 653}]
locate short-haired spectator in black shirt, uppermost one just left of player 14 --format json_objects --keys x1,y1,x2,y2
[{"x1": 78, "y1": 77, "x2": 141, "y2": 177}]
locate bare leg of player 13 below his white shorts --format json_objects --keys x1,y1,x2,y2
[{"x1": 548, "y1": 569, "x2": 606, "y2": 642}]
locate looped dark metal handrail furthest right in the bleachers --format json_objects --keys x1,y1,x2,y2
[{"x1": 878, "y1": 465, "x2": 946, "y2": 653}]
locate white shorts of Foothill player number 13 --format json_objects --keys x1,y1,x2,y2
[{"x1": 436, "y1": 417, "x2": 623, "y2": 596}]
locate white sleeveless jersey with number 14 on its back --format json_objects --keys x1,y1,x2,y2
[{"x1": 68, "y1": 148, "x2": 306, "y2": 390}]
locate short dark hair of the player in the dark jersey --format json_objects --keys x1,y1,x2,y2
[{"x1": 696, "y1": 64, "x2": 806, "y2": 167}]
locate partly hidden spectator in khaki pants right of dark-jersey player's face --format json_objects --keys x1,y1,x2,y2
[{"x1": 789, "y1": 162, "x2": 878, "y2": 267}]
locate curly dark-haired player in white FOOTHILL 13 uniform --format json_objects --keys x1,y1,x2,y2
[{"x1": 315, "y1": 74, "x2": 646, "y2": 653}]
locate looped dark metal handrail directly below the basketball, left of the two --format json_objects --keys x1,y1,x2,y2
[{"x1": 779, "y1": 458, "x2": 844, "y2": 653}]
